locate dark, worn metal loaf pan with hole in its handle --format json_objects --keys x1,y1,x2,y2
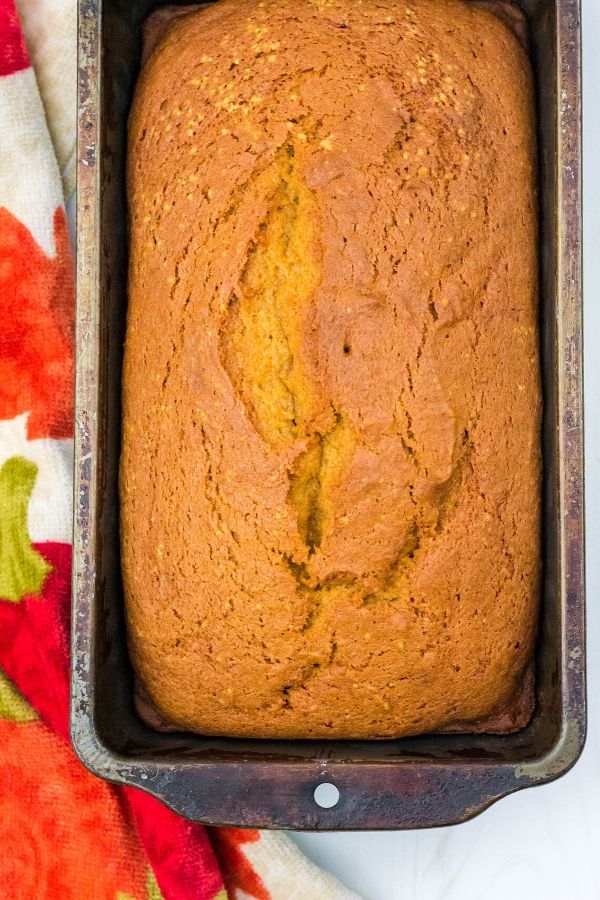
[{"x1": 71, "y1": 0, "x2": 586, "y2": 830}]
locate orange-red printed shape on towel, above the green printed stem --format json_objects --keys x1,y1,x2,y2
[{"x1": 0, "y1": 208, "x2": 74, "y2": 439}]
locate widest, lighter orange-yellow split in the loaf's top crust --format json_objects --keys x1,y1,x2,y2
[{"x1": 221, "y1": 143, "x2": 321, "y2": 448}]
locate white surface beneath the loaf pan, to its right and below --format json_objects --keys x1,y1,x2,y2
[{"x1": 294, "y1": 0, "x2": 600, "y2": 900}]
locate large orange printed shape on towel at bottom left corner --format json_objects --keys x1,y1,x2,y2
[{"x1": 0, "y1": 720, "x2": 148, "y2": 900}]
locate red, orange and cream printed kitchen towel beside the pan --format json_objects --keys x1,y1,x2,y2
[{"x1": 0, "y1": 0, "x2": 357, "y2": 900}]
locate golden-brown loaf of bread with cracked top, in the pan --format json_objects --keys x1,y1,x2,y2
[{"x1": 122, "y1": 0, "x2": 540, "y2": 737}]
